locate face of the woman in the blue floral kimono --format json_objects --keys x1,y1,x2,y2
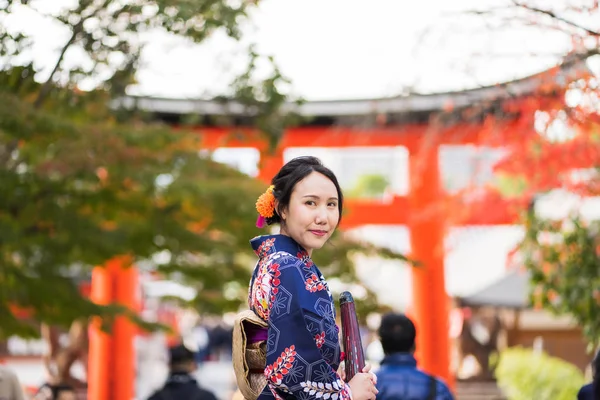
[{"x1": 281, "y1": 172, "x2": 340, "y2": 255}]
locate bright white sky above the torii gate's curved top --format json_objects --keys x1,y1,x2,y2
[{"x1": 7, "y1": 0, "x2": 569, "y2": 100}]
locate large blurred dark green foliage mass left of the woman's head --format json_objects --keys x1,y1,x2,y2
[{"x1": 0, "y1": 84, "x2": 262, "y2": 335}]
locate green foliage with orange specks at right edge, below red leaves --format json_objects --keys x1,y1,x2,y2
[{"x1": 521, "y1": 213, "x2": 600, "y2": 348}]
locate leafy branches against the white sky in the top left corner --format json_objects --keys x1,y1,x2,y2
[{"x1": 0, "y1": 0, "x2": 255, "y2": 106}]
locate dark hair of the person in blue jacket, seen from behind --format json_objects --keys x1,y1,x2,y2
[{"x1": 379, "y1": 313, "x2": 417, "y2": 355}]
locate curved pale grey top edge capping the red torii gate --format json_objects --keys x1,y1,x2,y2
[{"x1": 118, "y1": 54, "x2": 589, "y2": 121}]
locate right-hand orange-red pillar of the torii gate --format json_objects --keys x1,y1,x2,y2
[{"x1": 409, "y1": 145, "x2": 451, "y2": 382}]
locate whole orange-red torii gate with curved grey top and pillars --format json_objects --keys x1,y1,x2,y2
[{"x1": 88, "y1": 60, "x2": 587, "y2": 400}]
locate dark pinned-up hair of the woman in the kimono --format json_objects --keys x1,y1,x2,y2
[{"x1": 267, "y1": 156, "x2": 344, "y2": 225}]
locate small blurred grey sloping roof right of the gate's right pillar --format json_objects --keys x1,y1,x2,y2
[{"x1": 461, "y1": 268, "x2": 530, "y2": 309}]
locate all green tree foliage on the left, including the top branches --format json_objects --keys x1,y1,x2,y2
[{"x1": 0, "y1": 0, "x2": 403, "y2": 336}]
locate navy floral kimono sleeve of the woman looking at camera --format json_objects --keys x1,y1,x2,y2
[{"x1": 265, "y1": 259, "x2": 351, "y2": 400}]
